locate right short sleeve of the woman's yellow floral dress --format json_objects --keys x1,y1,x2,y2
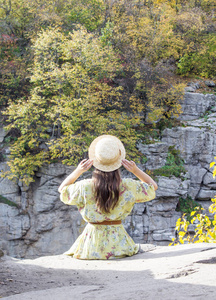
[{"x1": 133, "y1": 180, "x2": 156, "y2": 203}]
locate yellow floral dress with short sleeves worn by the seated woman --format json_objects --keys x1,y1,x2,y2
[{"x1": 60, "y1": 178, "x2": 155, "y2": 259}]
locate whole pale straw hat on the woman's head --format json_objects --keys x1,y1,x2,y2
[{"x1": 89, "y1": 134, "x2": 125, "y2": 172}]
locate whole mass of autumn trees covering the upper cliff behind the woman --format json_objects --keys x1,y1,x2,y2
[{"x1": 0, "y1": 0, "x2": 216, "y2": 183}]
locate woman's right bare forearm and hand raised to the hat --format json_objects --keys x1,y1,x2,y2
[{"x1": 122, "y1": 159, "x2": 158, "y2": 191}]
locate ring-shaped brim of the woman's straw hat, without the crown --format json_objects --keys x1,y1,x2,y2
[{"x1": 88, "y1": 134, "x2": 126, "y2": 172}]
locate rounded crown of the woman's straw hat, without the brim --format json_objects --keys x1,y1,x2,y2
[{"x1": 95, "y1": 138, "x2": 121, "y2": 165}]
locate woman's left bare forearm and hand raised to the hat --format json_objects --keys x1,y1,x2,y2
[{"x1": 58, "y1": 159, "x2": 93, "y2": 193}]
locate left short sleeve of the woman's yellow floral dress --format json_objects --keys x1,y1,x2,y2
[{"x1": 60, "y1": 181, "x2": 84, "y2": 206}]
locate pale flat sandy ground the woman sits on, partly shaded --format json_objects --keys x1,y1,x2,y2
[{"x1": 0, "y1": 244, "x2": 216, "y2": 300}]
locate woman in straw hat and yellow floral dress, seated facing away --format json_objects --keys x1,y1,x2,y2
[{"x1": 59, "y1": 135, "x2": 157, "y2": 259}]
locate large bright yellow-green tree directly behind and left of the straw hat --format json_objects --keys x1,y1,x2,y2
[{"x1": 2, "y1": 28, "x2": 139, "y2": 184}]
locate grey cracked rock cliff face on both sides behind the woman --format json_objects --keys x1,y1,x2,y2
[{"x1": 0, "y1": 93, "x2": 216, "y2": 258}]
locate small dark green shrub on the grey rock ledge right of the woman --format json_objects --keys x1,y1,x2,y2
[{"x1": 153, "y1": 146, "x2": 186, "y2": 177}]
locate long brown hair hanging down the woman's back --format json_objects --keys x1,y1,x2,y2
[{"x1": 93, "y1": 169, "x2": 121, "y2": 213}]
